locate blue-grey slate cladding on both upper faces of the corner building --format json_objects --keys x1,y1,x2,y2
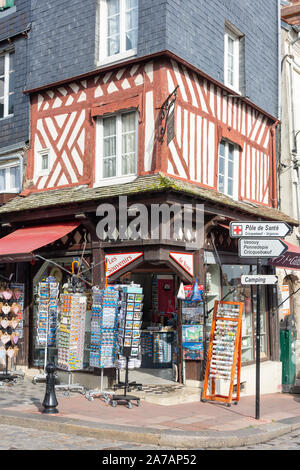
[{"x1": 27, "y1": 0, "x2": 278, "y2": 115}]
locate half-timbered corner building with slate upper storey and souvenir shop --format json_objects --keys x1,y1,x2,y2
[{"x1": 0, "y1": 0, "x2": 298, "y2": 394}]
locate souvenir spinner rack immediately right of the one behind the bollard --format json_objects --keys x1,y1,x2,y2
[{"x1": 55, "y1": 293, "x2": 87, "y2": 394}]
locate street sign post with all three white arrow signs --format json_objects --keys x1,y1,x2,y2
[{"x1": 229, "y1": 220, "x2": 292, "y2": 419}]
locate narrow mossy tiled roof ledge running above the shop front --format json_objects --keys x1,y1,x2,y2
[{"x1": 0, "y1": 173, "x2": 300, "y2": 225}]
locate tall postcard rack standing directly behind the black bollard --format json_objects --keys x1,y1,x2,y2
[{"x1": 33, "y1": 277, "x2": 59, "y2": 383}]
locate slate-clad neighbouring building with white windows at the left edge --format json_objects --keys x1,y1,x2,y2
[{"x1": 0, "y1": 0, "x2": 31, "y2": 204}]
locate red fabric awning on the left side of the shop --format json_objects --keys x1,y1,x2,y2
[{"x1": 0, "y1": 222, "x2": 80, "y2": 263}]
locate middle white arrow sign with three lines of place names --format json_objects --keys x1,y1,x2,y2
[{"x1": 239, "y1": 238, "x2": 288, "y2": 258}]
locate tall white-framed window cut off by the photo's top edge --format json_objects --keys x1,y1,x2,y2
[{"x1": 99, "y1": 0, "x2": 138, "y2": 62}]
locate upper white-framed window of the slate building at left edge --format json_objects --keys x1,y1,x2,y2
[{"x1": 0, "y1": 52, "x2": 15, "y2": 119}]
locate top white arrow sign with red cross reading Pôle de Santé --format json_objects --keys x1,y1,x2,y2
[{"x1": 229, "y1": 222, "x2": 292, "y2": 238}]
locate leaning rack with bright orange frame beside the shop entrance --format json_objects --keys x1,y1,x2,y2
[{"x1": 201, "y1": 301, "x2": 243, "y2": 406}]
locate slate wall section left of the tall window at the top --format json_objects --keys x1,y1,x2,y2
[{"x1": 27, "y1": 0, "x2": 97, "y2": 88}]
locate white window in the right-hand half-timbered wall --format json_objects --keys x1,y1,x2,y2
[{"x1": 218, "y1": 140, "x2": 239, "y2": 199}]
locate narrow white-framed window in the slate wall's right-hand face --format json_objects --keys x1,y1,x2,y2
[{"x1": 224, "y1": 27, "x2": 240, "y2": 92}]
